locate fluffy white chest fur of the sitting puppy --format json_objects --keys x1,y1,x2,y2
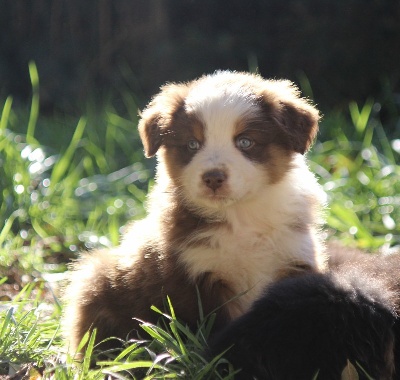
[{"x1": 181, "y1": 168, "x2": 325, "y2": 317}]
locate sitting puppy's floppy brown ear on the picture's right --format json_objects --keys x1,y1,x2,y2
[{"x1": 264, "y1": 80, "x2": 320, "y2": 154}]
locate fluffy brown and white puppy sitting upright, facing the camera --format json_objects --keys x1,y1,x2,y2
[{"x1": 64, "y1": 71, "x2": 326, "y2": 350}]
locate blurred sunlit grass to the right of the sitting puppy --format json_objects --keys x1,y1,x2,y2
[{"x1": 310, "y1": 100, "x2": 400, "y2": 250}]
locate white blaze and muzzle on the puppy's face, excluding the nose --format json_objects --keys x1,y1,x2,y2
[{"x1": 177, "y1": 74, "x2": 267, "y2": 211}]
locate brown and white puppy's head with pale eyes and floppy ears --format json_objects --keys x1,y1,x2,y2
[{"x1": 139, "y1": 72, "x2": 319, "y2": 214}]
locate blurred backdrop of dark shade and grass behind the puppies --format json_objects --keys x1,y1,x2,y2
[{"x1": 0, "y1": 0, "x2": 400, "y2": 284}]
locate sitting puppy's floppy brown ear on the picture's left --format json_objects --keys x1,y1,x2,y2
[{"x1": 138, "y1": 83, "x2": 188, "y2": 157}]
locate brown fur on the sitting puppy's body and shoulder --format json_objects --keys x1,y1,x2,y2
[{"x1": 64, "y1": 197, "x2": 235, "y2": 350}]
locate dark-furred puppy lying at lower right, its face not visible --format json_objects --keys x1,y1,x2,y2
[{"x1": 210, "y1": 254, "x2": 400, "y2": 380}]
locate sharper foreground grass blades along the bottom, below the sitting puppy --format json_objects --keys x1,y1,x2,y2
[{"x1": 0, "y1": 278, "x2": 231, "y2": 380}]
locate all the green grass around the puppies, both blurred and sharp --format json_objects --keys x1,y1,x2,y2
[{"x1": 0, "y1": 64, "x2": 400, "y2": 379}]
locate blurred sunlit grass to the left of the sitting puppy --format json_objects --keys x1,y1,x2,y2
[{"x1": 0, "y1": 68, "x2": 151, "y2": 275}]
